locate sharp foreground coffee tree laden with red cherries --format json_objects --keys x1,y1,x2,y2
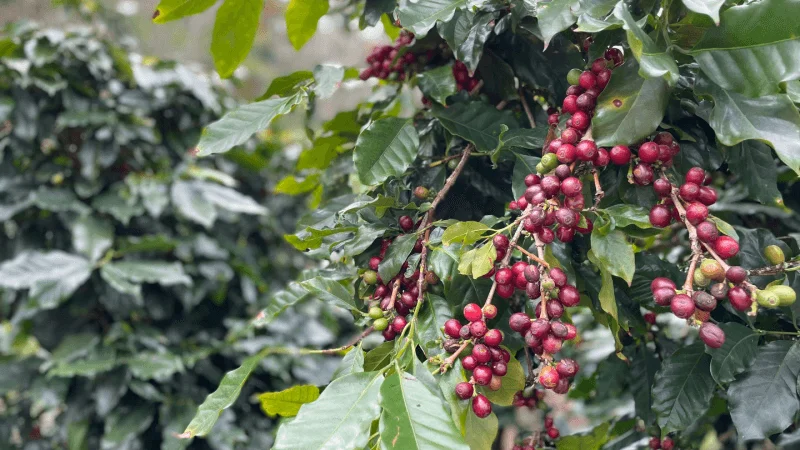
[{"x1": 154, "y1": 0, "x2": 800, "y2": 449}]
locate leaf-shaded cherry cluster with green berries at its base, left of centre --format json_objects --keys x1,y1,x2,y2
[{"x1": 362, "y1": 216, "x2": 439, "y2": 341}]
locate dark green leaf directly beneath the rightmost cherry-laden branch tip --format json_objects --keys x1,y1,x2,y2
[{"x1": 706, "y1": 322, "x2": 759, "y2": 384}]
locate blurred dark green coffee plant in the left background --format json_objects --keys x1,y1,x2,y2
[{"x1": 0, "y1": 23, "x2": 360, "y2": 450}]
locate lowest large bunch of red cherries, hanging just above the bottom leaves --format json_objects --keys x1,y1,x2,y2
[{"x1": 444, "y1": 303, "x2": 511, "y2": 418}]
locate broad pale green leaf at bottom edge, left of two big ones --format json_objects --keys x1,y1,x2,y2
[{"x1": 272, "y1": 372, "x2": 383, "y2": 450}]
